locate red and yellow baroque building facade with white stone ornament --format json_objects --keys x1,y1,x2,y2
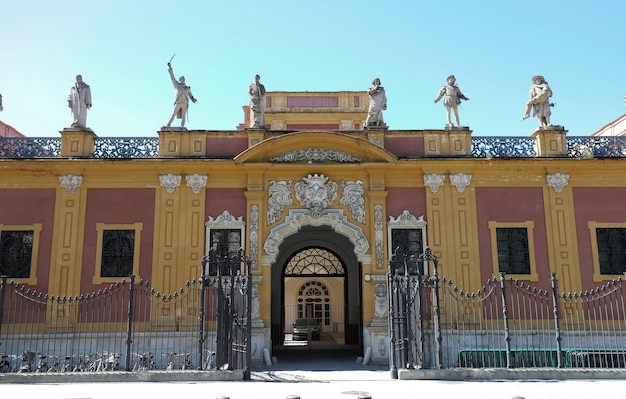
[{"x1": 0, "y1": 92, "x2": 626, "y2": 368}]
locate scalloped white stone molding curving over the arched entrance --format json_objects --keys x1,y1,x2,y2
[{"x1": 262, "y1": 209, "x2": 371, "y2": 266}]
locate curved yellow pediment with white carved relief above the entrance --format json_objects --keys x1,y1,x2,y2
[{"x1": 235, "y1": 132, "x2": 397, "y2": 163}]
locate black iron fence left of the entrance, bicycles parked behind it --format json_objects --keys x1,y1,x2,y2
[{"x1": 0, "y1": 273, "x2": 250, "y2": 376}]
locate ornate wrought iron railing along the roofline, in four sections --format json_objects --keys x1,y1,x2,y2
[{"x1": 0, "y1": 136, "x2": 626, "y2": 159}]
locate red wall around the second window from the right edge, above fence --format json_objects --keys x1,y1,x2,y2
[{"x1": 476, "y1": 187, "x2": 558, "y2": 289}]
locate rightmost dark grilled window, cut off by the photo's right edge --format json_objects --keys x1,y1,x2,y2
[{"x1": 596, "y1": 228, "x2": 626, "y2": 274}]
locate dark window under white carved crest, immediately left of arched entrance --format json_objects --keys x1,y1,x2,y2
[{"x1": 209, "y1": 229, "x2": 242, "y2": 276}]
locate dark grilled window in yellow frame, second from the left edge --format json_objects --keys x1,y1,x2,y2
[{"x1": 100, "y1": 230, "x2": 135, "y2": 277}]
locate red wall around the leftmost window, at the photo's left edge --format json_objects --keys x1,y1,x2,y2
[{"x1": 0, "y1": 189, "x2": 56, "y2": 292}]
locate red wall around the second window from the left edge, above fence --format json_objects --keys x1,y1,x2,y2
[{"x1": 80, "y1": 188, "x2": 155, "y2": 293}]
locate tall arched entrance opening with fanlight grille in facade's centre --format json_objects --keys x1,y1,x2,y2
[{"x1": 272, "y1": 226, "x2": 362, "y2": 349}]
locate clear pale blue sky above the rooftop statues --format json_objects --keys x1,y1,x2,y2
[{"x1": 0, "y1": 0, "x2": 626, "y2": 137}]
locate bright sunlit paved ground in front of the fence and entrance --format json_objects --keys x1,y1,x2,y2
[{"x1": 0, "y1": 352, "x2": 626, "y2": 399}]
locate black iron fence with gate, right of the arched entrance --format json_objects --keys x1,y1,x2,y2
[{"x1": 389, "y1": 252, "x2": 626, "y2": 375}]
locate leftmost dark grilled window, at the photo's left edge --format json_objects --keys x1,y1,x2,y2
[{"x1": 0, "y1": 230, "x2": 34, "y2": 278}]
